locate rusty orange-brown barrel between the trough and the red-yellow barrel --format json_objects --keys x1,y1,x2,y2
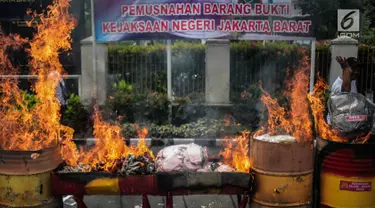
[{"x1": 250, "y1": 138, "x2": 314, "y2": 208}]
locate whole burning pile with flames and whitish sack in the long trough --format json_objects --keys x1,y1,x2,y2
[{"x1": 60, "y1": 103, "x2": 250, "y2": 175}]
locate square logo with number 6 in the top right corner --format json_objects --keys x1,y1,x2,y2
[{"x1": 337, "y1": 9, "x2": 359, "y2": 32}]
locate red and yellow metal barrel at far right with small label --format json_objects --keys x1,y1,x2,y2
[{"x1": 315, "y1": 139, "x2": 375, "y2": 208}]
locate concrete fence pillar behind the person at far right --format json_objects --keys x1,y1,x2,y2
[{"x1": 329, "y1": 37, "x2": 358, "y2": 88}]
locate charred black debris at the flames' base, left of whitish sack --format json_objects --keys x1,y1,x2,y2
[{"x1": 60, "y1": 154, "x2": 155, "y2": 176}]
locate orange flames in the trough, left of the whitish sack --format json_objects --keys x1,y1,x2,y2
[{"x1": 65, "y1": 105, "x2": 154, "y2": 171}]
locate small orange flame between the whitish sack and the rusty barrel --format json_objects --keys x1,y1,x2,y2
[{"x1": 220, "y1": 131, "x2": 250, "y2": 173}]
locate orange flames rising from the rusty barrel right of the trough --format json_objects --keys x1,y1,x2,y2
[{"x1": 255, "y1": 52, "x2": 312, "y2": 142}]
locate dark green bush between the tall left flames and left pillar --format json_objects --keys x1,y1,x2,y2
[{"x1": 61, "y1": 94, "x2": 90, "y2": 136}]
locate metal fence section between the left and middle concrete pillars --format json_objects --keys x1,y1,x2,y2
[{"x1": 108, "y1": 45, "x2": 205, "y2": 97}]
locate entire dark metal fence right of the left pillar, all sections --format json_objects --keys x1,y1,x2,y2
[{"x1": 109, "y1": 42, "x2": 375, "y2": 101}]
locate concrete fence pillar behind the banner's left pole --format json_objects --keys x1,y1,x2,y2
[{"x1": 81, "y1": 37, "x2": 108, "y2": 105}]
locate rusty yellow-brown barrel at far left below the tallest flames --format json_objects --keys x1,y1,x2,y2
[{"x1": 0, "y1": 146, "x2": 63, "y2": 208}]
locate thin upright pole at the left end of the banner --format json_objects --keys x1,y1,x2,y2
[{"x1": 91, "y1": 0, "x2": 98, "y2": 104}]
